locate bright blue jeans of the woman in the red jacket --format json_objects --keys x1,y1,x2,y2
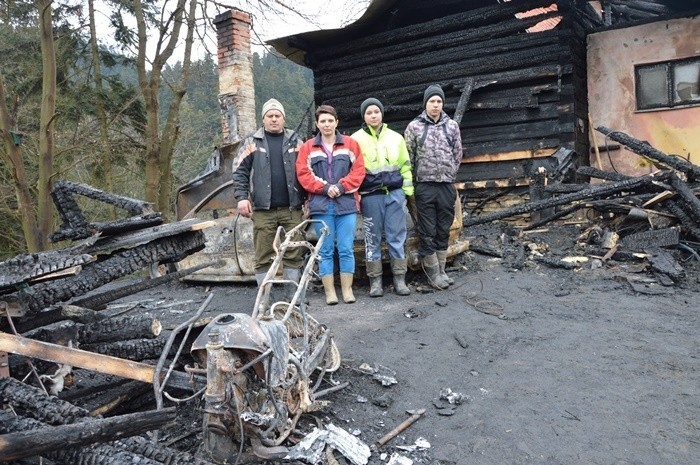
[{"x1": 313, "y1": 202, "x2": 357, "y2": 277}]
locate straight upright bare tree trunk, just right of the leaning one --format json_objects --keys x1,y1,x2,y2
[{"x1": 37, "y1": 0, "x2": 56, "y2": 250}]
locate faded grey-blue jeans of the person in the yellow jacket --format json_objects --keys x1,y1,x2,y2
[{"x1": 361, "y1": 189, "x2": 408, "y2": 262}]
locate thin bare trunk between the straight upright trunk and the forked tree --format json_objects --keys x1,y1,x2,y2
[{"x1": 88, "y1": 0, "x2": 117, "y2": 220}]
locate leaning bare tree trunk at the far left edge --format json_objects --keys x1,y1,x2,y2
[{"x1": 0, "y1": 73, "x2": 41, "y2": 253}]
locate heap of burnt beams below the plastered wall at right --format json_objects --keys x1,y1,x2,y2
[{"x1": 463, "y1": 126, "x2": 700, "y2": 284}]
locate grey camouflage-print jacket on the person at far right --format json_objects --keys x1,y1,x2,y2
[{"x1": 404, "y1": 111, "x2": 462, "y2": 182}]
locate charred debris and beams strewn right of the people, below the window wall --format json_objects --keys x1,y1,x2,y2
[{"x1": 463, "y1": 126, "x2": 700, "y2": 286}]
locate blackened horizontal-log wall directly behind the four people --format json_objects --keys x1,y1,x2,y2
[{"x1": 305, "y1": 0, "x2": 585, "y2": 187}]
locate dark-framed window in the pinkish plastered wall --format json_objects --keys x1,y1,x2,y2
[{"x1": 634, "y1": 57, "x2": 700, "y2": 110}]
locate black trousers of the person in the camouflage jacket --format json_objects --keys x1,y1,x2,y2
[{"x1": 414, "y1": 182, "x2": 457, "y2": 258}]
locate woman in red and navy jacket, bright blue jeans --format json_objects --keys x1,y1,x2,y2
[{"x1": 296, "y1": 105, "x2": 365, "y2": 305}]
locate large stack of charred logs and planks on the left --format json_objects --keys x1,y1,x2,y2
[{"x1": 0, "y1": 181, "x2": 213, "y2": 464}]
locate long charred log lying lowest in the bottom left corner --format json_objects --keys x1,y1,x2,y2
[{"x1": 0, "y1": 407, "x2": 175, "y2": 460}]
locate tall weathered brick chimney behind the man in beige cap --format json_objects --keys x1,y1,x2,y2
[{"x1": 214, "y1": 8, "x2": 257, "y2": 144}]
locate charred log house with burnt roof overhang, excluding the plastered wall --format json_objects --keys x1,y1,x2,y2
[{"x1": 270, "y1": 0, "x2": 700, "y2": 209}]
